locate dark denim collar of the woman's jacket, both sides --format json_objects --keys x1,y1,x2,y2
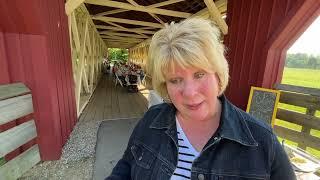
[{"x1": 150, "y1": 95, "x2": 258, "y2": 146}]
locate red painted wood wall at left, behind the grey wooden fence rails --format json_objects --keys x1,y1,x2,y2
[{"x1": 0, "y1": 0, "x2": 77, "y2": 160}]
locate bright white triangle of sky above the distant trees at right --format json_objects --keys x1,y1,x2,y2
[{"x1": 287, "y1": 16, "x2": 320, "y2": 55}]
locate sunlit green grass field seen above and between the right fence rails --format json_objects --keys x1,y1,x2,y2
[{"x1": 275, "y1": 68, "x2": 320, "y2": 159}]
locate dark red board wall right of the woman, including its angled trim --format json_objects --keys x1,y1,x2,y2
[{"x1": 225, "y1": 0, "x2": 320, "y2": 109}]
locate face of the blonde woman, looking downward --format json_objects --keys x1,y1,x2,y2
[{"x1": 165, "y1": 66, "x2": 219, "y2": 121}]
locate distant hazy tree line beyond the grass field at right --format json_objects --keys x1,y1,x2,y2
[{"x1": 285, "y1": 53, "x2": 320, "y2": 69}]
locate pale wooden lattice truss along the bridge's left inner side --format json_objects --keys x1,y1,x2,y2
[{"x1": 67, "y1": 1, "x2": 107, "y2": 115}]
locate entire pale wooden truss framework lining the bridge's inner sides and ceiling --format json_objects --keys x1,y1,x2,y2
[{"x1": 65, "y1": 0, "x2": 228, "y2": 111}]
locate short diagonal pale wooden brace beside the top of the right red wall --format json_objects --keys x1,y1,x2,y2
[{"x1": 204, "y1": 0, "x2": 228, "y2": 35}]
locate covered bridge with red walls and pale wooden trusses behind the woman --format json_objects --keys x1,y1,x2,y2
[{"x1": 0, "y1": 0, "x2": 320, "y2": 176}]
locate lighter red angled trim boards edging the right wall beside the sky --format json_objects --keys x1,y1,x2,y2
[{"x1": 259, "y1": 0, "x2": 320, "y2": 87}]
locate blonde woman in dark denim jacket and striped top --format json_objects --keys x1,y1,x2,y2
[{"x1": 107, "y1": 19, "x2": 295, "y2": 180}]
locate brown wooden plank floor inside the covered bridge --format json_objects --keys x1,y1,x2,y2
[{"x1": 80, "y1": 75, "x2": 149, "y2": 121}]
